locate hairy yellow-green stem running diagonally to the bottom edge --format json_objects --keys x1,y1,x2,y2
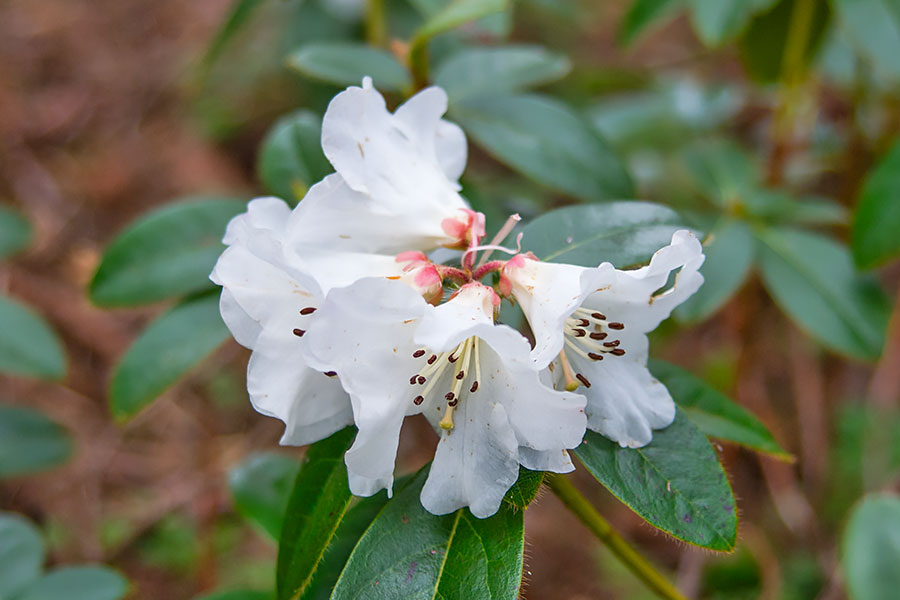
[{"x1": 544, "y1": 473, "x2": 686, "y2": 600}]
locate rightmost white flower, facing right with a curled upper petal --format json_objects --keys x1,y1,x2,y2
[{"x1": 500, "y1": 231, "x2": 704, "y2": 447}]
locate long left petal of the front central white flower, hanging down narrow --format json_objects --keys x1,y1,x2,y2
[{"x1": 304, "y1": 279, "x2": 427, "y2": 495}]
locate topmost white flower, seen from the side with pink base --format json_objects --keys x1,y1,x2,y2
[{"x1": 289, "y1": 77, "x2": 484, "y2": 254}]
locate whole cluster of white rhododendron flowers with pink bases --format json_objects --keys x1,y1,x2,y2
[{"x1": 211, "y1": 78, "x2": 703, "y2": 517}]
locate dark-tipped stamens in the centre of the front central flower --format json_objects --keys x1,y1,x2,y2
[{"x1": 409, "y1": 336, "x2": 481, "y2": 431}]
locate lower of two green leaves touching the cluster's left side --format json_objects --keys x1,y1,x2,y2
[{"x1": 110, "y1": 293, "x2": 228, "y2": 421}]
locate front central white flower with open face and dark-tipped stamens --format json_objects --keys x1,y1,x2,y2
[{"x1": 304, "y1": 279, "x2": 585, "y2": 517}]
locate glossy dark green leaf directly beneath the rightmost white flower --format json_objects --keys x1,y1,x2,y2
[{"x1": 575, "y1": 410, "x2": 737, "y2": 551}]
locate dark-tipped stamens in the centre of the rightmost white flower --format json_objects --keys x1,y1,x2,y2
[{"x1": 559, "y1": 308, "x2": 625, "y2": 391}]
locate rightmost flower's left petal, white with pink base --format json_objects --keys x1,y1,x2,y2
[{"x1": 503, "y1": 256, "x2": 615, "y2": 368}]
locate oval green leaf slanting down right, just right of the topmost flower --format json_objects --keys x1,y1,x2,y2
[{"x1": 452, "y1": 94, "x2": 633, "y2": 202}]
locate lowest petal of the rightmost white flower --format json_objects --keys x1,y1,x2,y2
[{"x1": 569, "y1": 354, "x2": 675, "y2": 448}]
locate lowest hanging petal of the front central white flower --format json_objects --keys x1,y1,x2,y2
[{"x1": 421, "y1": 398, "x2": 519, "y2": 519}]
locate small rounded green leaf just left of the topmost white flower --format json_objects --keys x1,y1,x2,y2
[{"x1": 256, "y1": 110, "x2": 333, "y2": 204}]
